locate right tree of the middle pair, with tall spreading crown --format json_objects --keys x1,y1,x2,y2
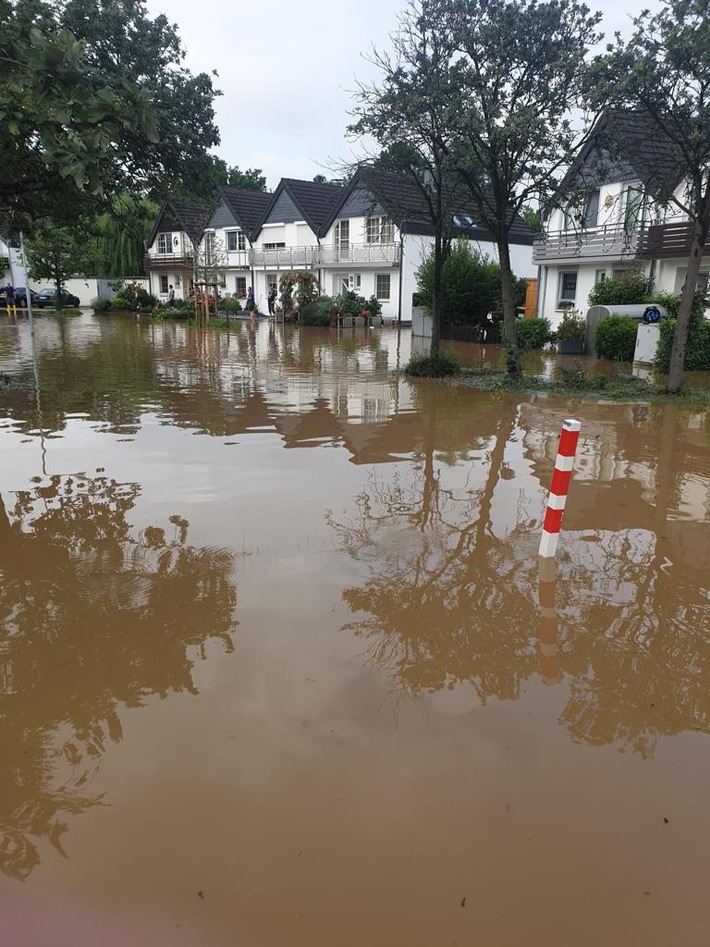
[{"x1": 442, "y1": 0, "x2": 601, "y2": 377}]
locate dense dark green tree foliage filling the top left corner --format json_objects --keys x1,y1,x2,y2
[{"x1": 0, "y1": 0, "x2": 219, "y2": 232}]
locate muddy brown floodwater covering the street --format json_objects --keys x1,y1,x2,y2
[{"x1": 0, "y1": 314, "x2": 710, "y2": 947}]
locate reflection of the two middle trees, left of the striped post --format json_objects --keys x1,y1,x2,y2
[{"x1": 329, "y1": 410, "x2": 536, "y2": 701}]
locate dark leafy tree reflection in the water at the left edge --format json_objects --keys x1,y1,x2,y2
[{"x1": 0, "y1": 476, "x2": 236, "y2": 879}]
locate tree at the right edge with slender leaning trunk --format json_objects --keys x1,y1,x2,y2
[{"x1": 589, "y1": 0, "x2": 710, "y2": 392}]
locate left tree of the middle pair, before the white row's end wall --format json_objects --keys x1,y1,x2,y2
[{"x1": 349, "y1": 0, "x2": 468, "y2": 353}]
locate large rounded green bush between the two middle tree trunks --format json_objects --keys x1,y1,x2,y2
[{"x1": 417, "y1": 240, "x2": 525, "y2": 326}]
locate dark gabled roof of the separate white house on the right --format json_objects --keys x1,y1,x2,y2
[{"x1": 560, "y1": 109, "x2": 683, "y2": 201}]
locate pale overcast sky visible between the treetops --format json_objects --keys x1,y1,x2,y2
[{"x1": 142, "y1": 0, "x2": 656, "y2": 189}]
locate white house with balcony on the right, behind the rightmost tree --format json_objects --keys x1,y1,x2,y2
[{"x1": 533, "y1": 111, "x2": 710, "y2": 327}]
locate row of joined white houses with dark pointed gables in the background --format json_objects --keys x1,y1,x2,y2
[{"x1": 145, "y1": 170, "x2": 536, "y2": 322}]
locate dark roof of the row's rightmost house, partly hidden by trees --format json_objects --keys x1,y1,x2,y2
[{"x1": 319, "y1": 167, "x2": 535, "y2": 245}]
